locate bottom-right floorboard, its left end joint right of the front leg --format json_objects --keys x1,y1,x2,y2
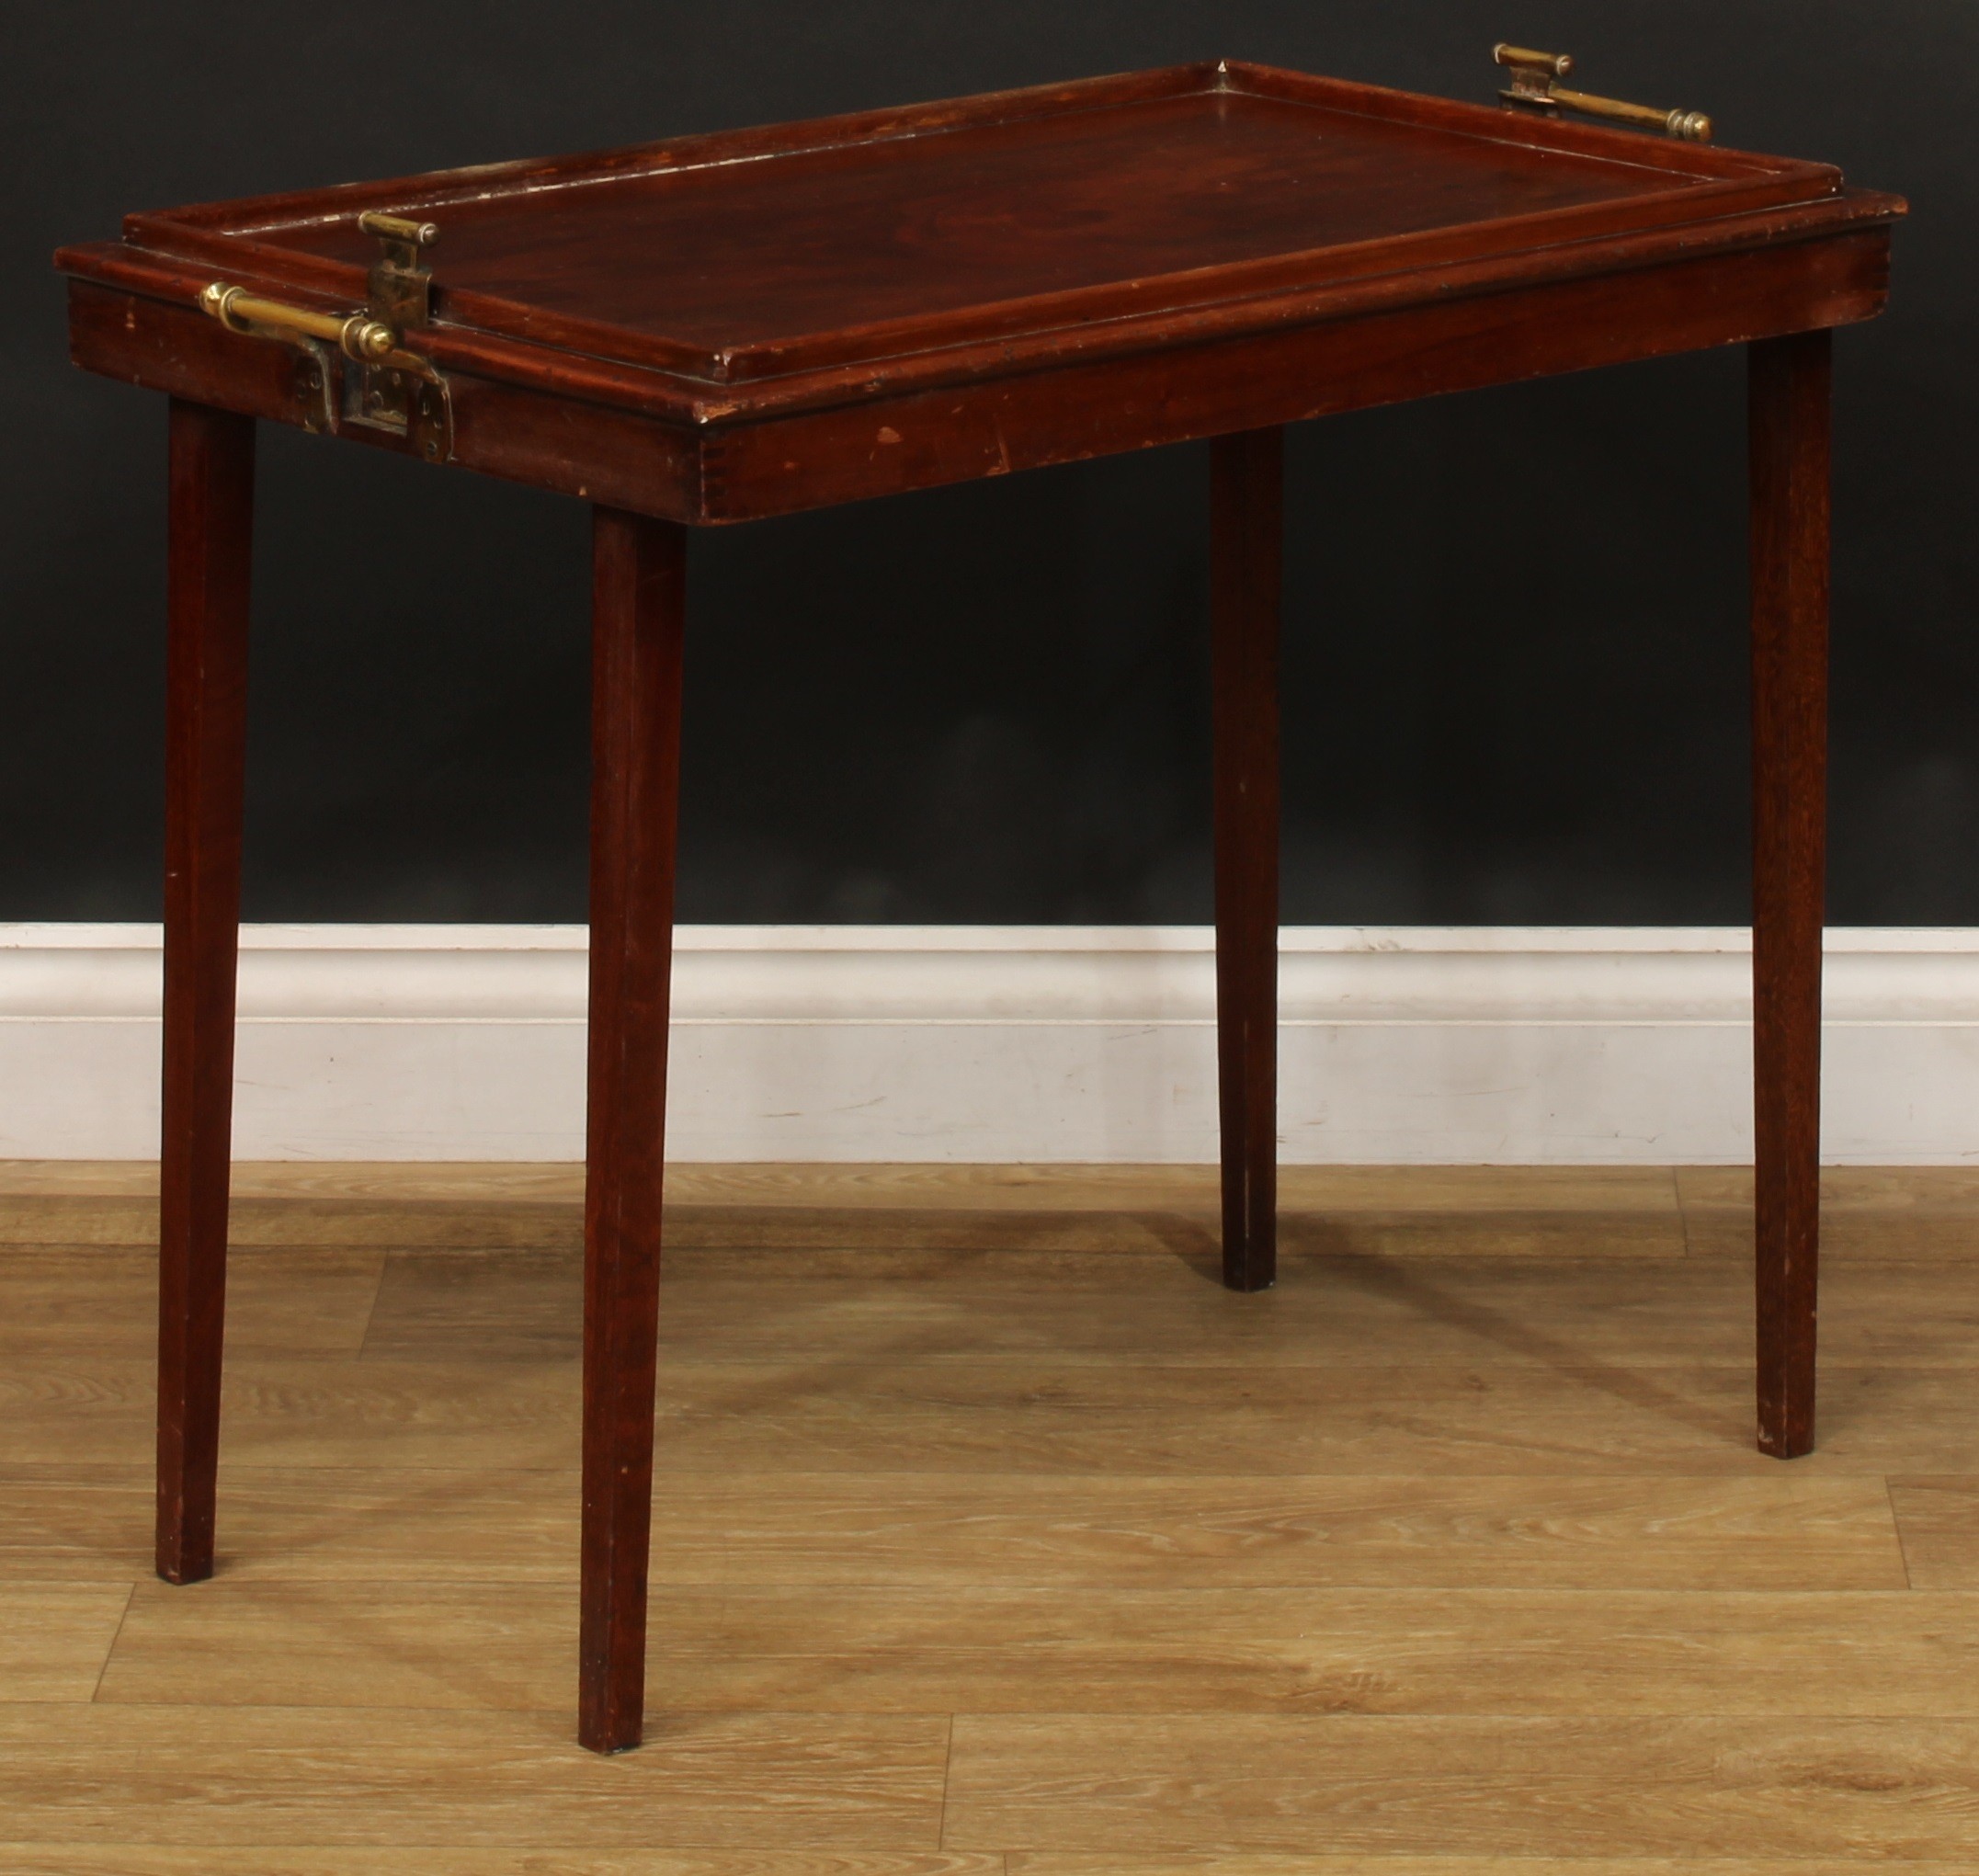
[{"x1": 944, "y1": 1713, "x2": 1979, "y2": 1862}]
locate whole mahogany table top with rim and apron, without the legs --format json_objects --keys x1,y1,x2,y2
[{"x1": 57, "y1": 65, "x2": 1904, "y2": 522}]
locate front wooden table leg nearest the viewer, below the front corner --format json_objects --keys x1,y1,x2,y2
[{"x1": 578, "y1": 508, "x2": 687, "y2": 1751}]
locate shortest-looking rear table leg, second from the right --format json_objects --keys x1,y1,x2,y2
[{"x1": 1209, "y1": 427, "x2": 1284, "y2": 1290}]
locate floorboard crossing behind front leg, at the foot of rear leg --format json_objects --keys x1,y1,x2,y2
[{"x1": 352, "y1": 1251, "x2": 1979, "y2": 1370}]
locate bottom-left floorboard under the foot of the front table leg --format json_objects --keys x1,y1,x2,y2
[{"x1": 0, "y1": 1704, "x2": 948, "y2": 1850}]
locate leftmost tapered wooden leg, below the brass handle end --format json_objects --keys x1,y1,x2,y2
[{"x1": 158, "y1": 398, "x2": 254, "y2": 1583}]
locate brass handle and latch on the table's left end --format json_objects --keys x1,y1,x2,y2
[{"x1": 199, "y1": 210, "x2": 453, "y2": 463}]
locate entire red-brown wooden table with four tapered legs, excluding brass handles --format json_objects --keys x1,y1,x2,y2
[{"x1": 57, "y1": 62, "x2": 1904, "y2": 1751}]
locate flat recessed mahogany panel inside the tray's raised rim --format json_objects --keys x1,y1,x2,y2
[{"x1": 259, "y1": 91, "x2": 1698, "y2": 376}]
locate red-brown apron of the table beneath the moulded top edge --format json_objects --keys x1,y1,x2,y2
[{"x1": 69, "y1": 225, "x2": 1890, "y2": 525}]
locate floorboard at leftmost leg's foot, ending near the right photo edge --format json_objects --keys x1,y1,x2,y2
[{"x1": 0, "y1": 1464, "x2": 1892, "y2": 1591}]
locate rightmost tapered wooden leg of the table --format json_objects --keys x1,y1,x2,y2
[{"x1": 1749, "y1": 333, "x2": 1831, "y2": 1459}]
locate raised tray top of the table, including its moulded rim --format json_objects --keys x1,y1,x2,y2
[{"x1": 69, "y1": 65, "x2": 1840, "y2": 384}]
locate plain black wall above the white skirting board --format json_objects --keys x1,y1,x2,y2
[{"x1": 0, "y1": 0, "x2": 1979, "y2": 924}]
